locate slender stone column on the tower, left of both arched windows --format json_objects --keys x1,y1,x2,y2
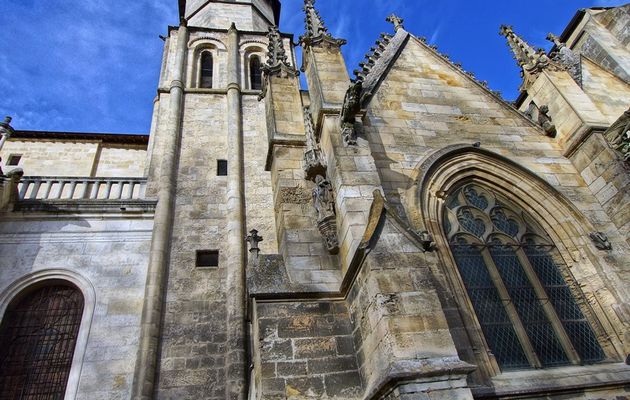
[{"x1": 132, "y1": 23, "x2": 188, "y2": 400}]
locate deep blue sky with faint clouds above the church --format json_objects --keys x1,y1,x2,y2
[{"x1": 0, "y1": 0, "x2": 627, "y2": 133}]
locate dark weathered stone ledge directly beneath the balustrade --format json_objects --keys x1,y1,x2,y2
[{"x1": 13, "y1": 200, "x2": 157, "y2": 214}]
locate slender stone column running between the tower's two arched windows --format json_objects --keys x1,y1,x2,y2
[{"x1": 226, "y1": 23, "x2": 247, "y2": 400}]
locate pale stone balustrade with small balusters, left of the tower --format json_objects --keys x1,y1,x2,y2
[{"x1": 18, "y1": 176, "x2": 147, "y2": 201}]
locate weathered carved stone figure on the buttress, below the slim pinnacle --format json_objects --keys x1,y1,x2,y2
[{"x1": 313, "y1": 175, "x2": 339, "y2": 254}]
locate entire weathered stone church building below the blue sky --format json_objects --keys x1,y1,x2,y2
[{"x1": 0, "y1": 0, "x2": 630, "y2": 400}]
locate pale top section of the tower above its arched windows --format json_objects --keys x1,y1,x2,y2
[{"x1": 179, "y1": 0, "x2": 280, "y2": 31}]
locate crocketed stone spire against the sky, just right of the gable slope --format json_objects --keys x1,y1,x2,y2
[{"x1": 500, "y1": 25, "x2": 555, "y2": 90}]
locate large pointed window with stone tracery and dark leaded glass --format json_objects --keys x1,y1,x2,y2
[{"x1": 443, "y1": 184, "x2": 605, "y2": 370}]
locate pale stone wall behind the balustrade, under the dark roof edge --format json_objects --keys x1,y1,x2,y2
[{"x1": 0, "y1": 138, "x2": 146, "y2": 177}]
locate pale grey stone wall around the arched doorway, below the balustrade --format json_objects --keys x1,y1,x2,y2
[{"x1": 0, "y1": 214, "x2": 153, "y2": 400}]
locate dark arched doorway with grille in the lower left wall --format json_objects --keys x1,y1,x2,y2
[{"x1": 0, "y1": 282, "x2": 83, "y2": 400}]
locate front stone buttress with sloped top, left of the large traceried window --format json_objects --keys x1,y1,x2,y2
[{"x1": 348, "y1": 217, "x2": 470, "y2": 399}]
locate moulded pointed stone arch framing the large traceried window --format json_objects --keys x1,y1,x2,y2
[{"x1": 409, "y1": 144, "x2": 624, "y2": 376}]
